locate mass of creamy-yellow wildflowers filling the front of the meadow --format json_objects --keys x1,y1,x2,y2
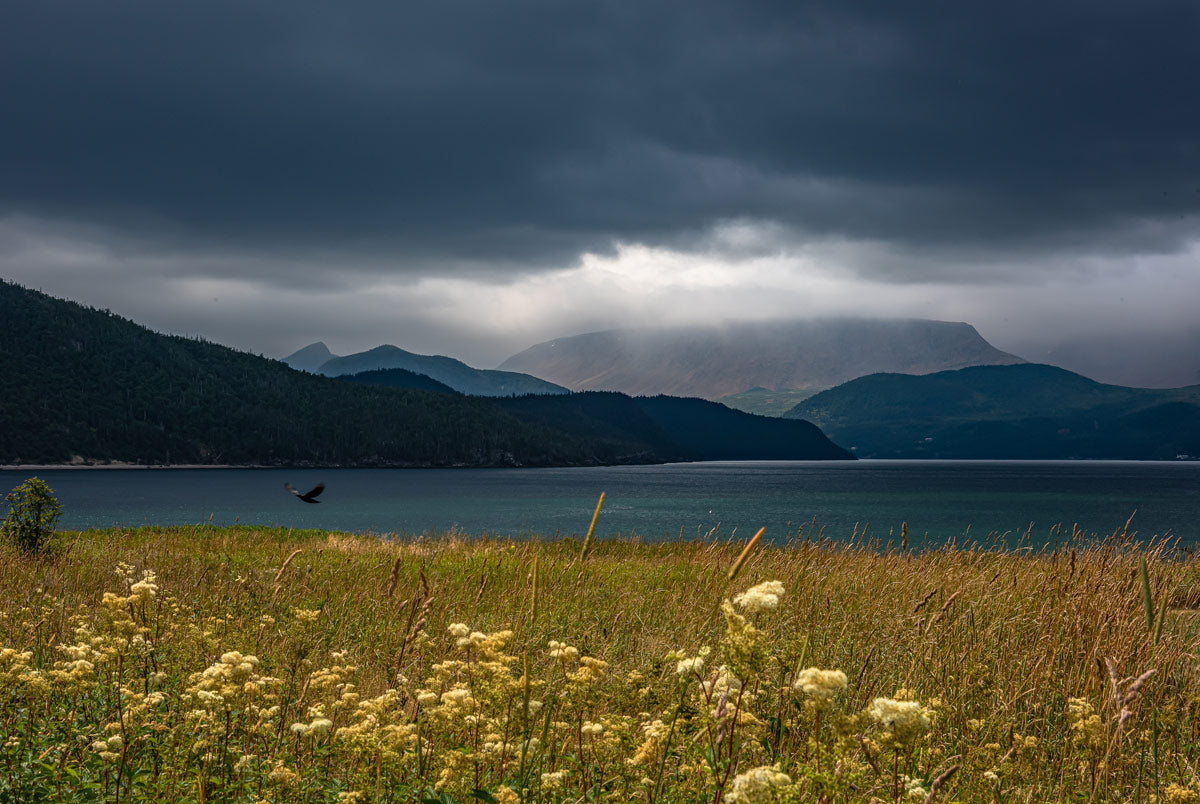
[{"x1": 14, "y1": 554, "x2": 1152, "y2": 804}]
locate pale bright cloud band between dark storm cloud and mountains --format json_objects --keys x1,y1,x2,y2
[{"x1": 0, "y1": 207, "x2": 1200, "y2": 384}]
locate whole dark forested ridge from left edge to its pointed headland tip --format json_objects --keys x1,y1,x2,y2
[{"x1": 0, "y1": 281, "x2": 851, "y2": 467}]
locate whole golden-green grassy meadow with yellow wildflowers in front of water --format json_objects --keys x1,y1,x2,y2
[{"x1": 0, "y1": 527, "x2": 1200, "y2": 804}]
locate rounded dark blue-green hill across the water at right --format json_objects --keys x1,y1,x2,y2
[{"x1": 787, "y1": 364, "x2": 1200, "y2": 460}]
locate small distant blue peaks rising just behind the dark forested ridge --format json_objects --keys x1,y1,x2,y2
[{"x1": 283, "y1": 341, "x2": 568, "y2": 396}]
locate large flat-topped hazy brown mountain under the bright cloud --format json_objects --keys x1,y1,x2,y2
[{"x1": 500, "y1": 319, "x2": 1022, "y2": 398}]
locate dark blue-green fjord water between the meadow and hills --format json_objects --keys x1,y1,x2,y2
[{"x1": 9, "y1": 461, "x2": 1200, "y2": 547}]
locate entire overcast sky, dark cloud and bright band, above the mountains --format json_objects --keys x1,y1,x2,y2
[{"x1": 0, "y1": 0, "x2": 1200, "y2": 382}]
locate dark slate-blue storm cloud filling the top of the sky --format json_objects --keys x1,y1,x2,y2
[{"x1": 0, "y1": 0, "x2": 1200, "y2": 272}]
